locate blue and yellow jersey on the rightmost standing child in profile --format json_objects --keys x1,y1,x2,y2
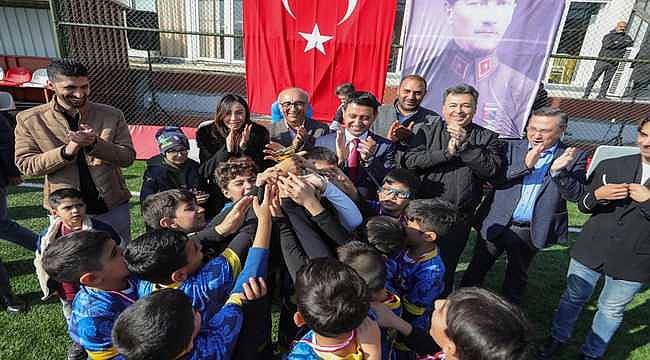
[{"x1": 389, "y1": 249, "x2": 445, "y2": 331}]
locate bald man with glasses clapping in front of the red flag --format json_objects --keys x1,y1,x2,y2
[{"x1": 267, "y1": 88, "x2": 329, "y2": 151}]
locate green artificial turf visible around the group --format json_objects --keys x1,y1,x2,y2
[{"x1": 0, "y1": 161, "x2": 650, "y2": 360}]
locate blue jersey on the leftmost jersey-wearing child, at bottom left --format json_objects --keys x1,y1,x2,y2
[{"x1": 68, "y1": 279, "x2": 138, "y2": 360}]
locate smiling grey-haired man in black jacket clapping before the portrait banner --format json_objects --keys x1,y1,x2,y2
[{"x1": 403, "y1": 84, "x2": 503, "y2": 296}]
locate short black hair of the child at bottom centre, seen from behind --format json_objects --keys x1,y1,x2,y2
[{"x1": 295, "y1": 258, "x2": 370, "y2": 337}]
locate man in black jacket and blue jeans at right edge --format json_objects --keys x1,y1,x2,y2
[{"x1": 538, "y1": 118, "x2": 650, "y2": 359}]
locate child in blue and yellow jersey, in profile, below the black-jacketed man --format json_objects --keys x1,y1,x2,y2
[{"x1": 388, "y1": 199, "x2": 455, "y2": 359}]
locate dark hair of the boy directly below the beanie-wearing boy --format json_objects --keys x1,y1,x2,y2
[{"x1": 141, "y1": 189, "x2": 196, "y2": 229}]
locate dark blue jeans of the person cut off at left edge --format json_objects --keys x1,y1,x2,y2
[{"x1": 0, "y1": 187, "x2": 38, "y2": 297}]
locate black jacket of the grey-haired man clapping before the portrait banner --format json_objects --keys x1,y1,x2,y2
[{"x1": 403, "y1": 121, "x2": 503, "y2": 215}]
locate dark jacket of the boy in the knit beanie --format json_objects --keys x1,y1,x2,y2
[{"x1": 140, "y1": 155, "x2": 206, "y2": 203}]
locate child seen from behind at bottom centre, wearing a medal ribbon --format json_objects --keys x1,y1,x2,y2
[{"x1": 285, "y1": 258, "x2": 381, "y2": 360}]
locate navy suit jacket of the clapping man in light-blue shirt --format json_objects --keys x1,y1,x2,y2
[{"x1": 481, "y1": 139, "x2": 587, "y2": 249}]
